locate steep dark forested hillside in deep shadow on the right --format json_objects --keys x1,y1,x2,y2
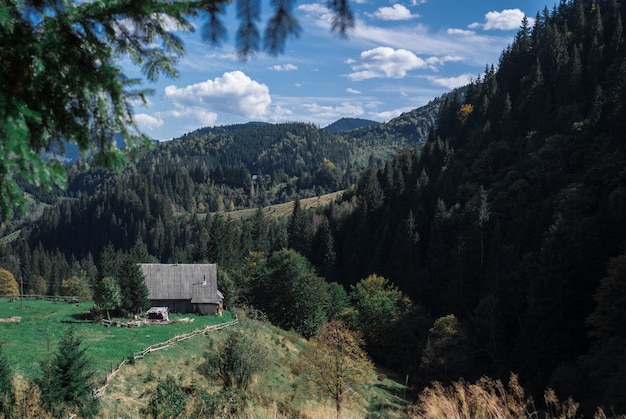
[{"x1": 324, "y1": 0, "x2": 626, "y2": 411}]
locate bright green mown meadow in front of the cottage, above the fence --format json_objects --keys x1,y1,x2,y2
[{"x1": 0, "y1": 299, "x2": 233, "y2": 377}]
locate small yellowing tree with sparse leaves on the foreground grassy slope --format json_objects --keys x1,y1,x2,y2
[{"x1": 300, "y1": 320, "x2": 374, "y2": 418}]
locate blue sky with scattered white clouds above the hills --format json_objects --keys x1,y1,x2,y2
[{"x1": 129, "y1": 0, "x2": 554, "y2": 141}]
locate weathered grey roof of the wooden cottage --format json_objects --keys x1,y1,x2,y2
[{"x1": 139, "y1": 263, "x2": 224, "y2": 304}]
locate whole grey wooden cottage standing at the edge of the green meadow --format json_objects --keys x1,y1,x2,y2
[{"x1": 139, "y1": 263, "x2": 224, "y2": 314}]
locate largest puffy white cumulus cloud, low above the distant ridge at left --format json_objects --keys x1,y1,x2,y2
[{"x1": 165, "y1": 71, "x2": 272, "y2": 123}]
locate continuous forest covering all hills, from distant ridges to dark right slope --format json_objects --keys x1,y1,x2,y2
[{"x1": 0, "y1": 0, "x2": 626, "y2": 416}]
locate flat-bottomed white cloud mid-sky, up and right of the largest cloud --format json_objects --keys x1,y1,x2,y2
[{"x1": 346, "y1": 47, "x2": 427, "y2": 81}]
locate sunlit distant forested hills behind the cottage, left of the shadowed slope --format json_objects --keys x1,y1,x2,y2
[{"x1": 1, "y1": 110, "x2": 434, "y2": 294}]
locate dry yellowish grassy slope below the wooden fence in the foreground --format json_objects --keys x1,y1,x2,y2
[{"x1": 101, "y1": 320, "x2": 406, "y2": 419}]
